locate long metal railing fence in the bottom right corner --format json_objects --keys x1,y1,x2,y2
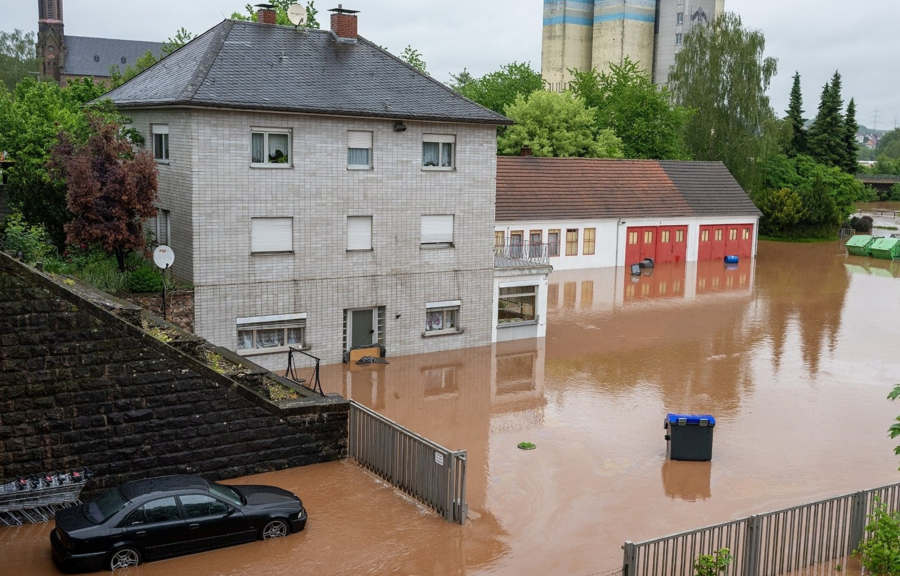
[{"x1": 623, "y1": 484, "x2": 900, "y2": 576}]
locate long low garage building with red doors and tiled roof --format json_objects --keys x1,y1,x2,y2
[{"x1": 494, "y1": 156, "x2": 760, "y2": 270}]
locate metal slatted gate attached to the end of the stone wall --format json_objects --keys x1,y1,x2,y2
[{"x1": 349, "y1": 400, "x2": 468, "y2": 524}]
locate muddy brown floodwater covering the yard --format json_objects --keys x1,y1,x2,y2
[{"x1": 7, "y1": 242, "x2": 900, "y2": 576}]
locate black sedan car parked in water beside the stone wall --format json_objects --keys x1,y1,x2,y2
[{"x1": 50, "y1": 475, "x2": 306, "y2": 571}]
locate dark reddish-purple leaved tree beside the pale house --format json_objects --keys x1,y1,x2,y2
[{"x1": 50, "y1": 116, "x2": 157, "y2": 272}]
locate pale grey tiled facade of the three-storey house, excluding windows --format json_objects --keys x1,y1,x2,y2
[{"x1": 128, "y1": 108, "x2": 496, "y2": 369}]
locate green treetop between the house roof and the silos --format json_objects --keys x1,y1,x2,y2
[{"x1": 450, "y1": 62, "x2": 544, "y2": 114}]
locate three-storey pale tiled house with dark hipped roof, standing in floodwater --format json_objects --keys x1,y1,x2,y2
[{"x1": 96, "y1": 9, "x2": 550, "y2": 368}]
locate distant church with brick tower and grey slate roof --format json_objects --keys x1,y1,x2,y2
[{"x1": 37, "y1": 0, "x2": 162, "y2": 86}]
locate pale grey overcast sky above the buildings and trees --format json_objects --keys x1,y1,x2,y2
[{"x1": 7, "y1": 0, "x2": 900, "y2": 129}]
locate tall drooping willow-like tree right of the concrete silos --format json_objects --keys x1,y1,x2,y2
[{"x1": 669, "y1": 12, "x2": 777, "y2": 189}]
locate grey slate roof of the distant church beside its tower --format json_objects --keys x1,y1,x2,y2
[{"x1": 63, "y1": 34, "x2": 162, "y2": 77}]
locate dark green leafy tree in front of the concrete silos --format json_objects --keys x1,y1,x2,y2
[{"x1": 570, "y1": 57, "x2": 692, "y2": 160}]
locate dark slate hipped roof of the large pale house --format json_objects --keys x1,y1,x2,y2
[{"x1": 104, "y1": 20, "x2": 512, "y2": 125}]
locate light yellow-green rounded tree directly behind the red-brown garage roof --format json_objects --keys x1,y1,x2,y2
[{"x1": 497, "y1": 90, "x2": 623, "y2": 158}]
